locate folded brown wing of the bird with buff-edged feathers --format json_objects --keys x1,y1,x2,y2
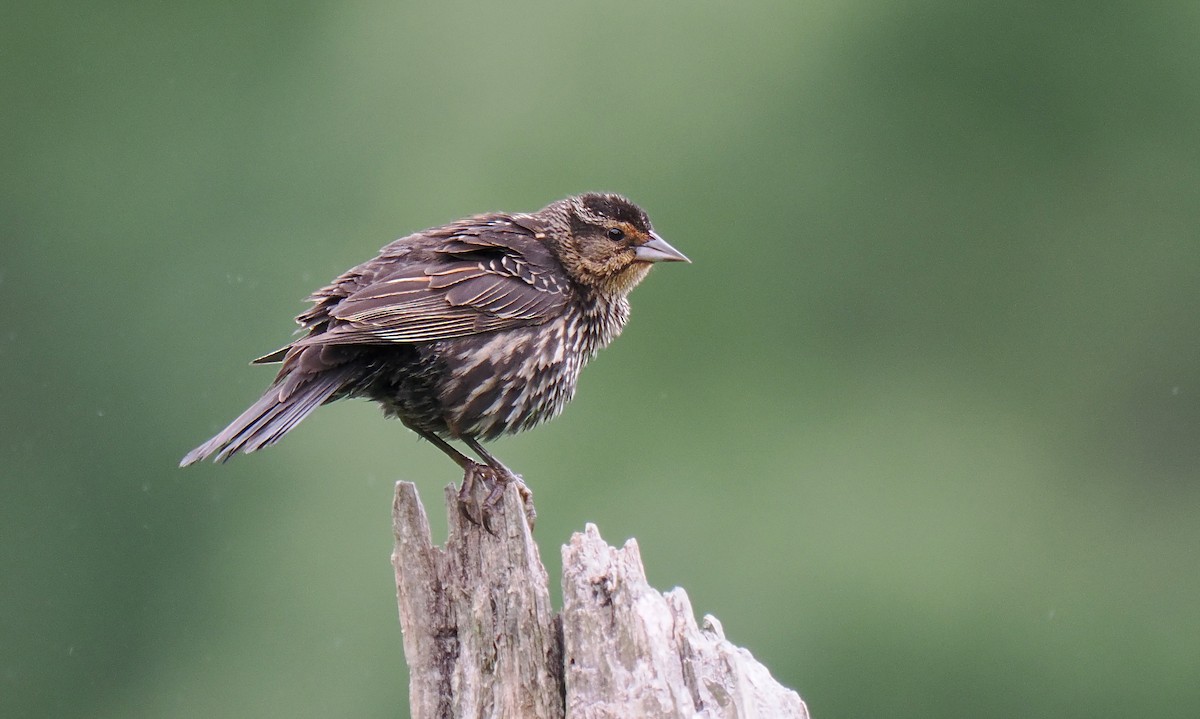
[{"x1": 293, "y1": 226, "x2": 571, "y2": 347}]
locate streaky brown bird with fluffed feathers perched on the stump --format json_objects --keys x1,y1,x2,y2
[{"x1": 180, "y1": 192, "x2": 691, "y2": 520}]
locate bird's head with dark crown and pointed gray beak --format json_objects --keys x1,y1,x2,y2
[{"x1": 542, "y1": 192, "x2": 691, "y2": 296}]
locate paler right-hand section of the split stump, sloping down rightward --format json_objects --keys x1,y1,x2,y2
[{"x1": 563, "y1": 525, "x2": 809, "y2": 719}]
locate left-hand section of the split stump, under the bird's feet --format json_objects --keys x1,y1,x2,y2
[{"x1": 392, "y1": 483, "x2": 563, "y2": 719}]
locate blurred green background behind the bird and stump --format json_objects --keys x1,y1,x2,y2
[{"x1": 0, "y1": 0, "x2": 1200, "y2": 719}]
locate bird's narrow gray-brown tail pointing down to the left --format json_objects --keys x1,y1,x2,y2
[{"x1": 179, "y1": 366, "x2": 353, "y2": 467}]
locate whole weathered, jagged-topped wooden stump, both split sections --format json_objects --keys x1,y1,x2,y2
[{"x1": 392, "y1": 483, "x2": 809, "y2": 719}]
